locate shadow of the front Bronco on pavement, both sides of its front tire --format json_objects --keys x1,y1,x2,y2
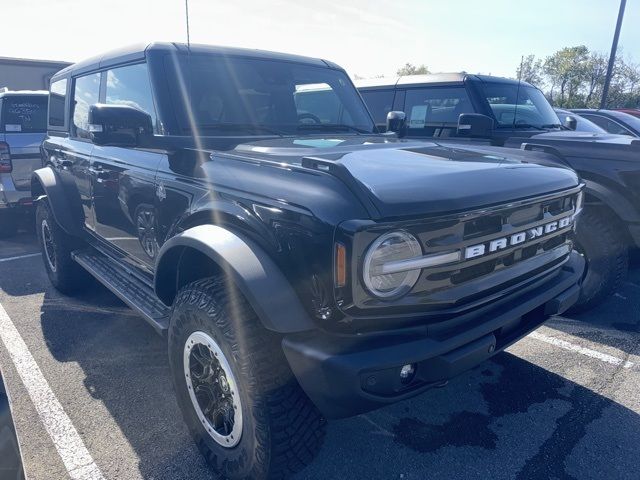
[{"x1": 36, "y1": 287, "x2": 640, "y2": 480}]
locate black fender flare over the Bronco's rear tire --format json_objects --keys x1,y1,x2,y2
[{"x1": 31, "y1": 167, "x2": 82, "y2": 237}]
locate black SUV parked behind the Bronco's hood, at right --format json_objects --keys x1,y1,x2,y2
[{"x1": 357, "y1": 73, "x2": 640, "y2": 310}]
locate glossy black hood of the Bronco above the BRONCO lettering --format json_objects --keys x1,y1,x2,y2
[{"x1": 235, "y1": 137, "x2": 579, "y2": 218}]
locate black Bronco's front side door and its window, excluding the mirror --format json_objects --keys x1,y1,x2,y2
[{"x1": 91, "y1": 63, "x2": 166, "y2": 271}]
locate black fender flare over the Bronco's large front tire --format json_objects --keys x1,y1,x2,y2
[{"x1": 154, "y1": 225, "x2": 316, "y2": 333}]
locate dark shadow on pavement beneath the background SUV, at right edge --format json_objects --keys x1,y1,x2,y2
[{"x1": 547, "y1": 267, "x2": 640, "y2": 355}]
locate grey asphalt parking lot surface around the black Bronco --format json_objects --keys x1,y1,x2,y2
[{"x1": 0, "y1": 234, "x2": 640, "y2": 480}]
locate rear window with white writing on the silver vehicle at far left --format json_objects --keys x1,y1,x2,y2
[{"x1": 0, "y1": 95, "x2": 47, "y2": 133}]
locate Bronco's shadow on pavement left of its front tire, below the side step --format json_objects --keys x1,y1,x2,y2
[{"x1": 41, "y1": 285, "x2": 214, "y2": 480}]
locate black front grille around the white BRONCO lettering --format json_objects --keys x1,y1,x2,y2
[{"x1": 348, "y1": 188, "x2": 579, "y2": 316}]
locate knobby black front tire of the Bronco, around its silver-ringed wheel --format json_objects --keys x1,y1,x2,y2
[{"x1": 168, "y1": 278, "x2": 325, "y2": 480}]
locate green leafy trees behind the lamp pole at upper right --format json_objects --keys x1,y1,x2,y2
[{"x1": 516, "y1": 45, "x2": 640, "y2": 108}]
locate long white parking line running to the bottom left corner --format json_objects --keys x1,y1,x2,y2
[{"x1": 0, "y1": 304, "x2": 104, "y2": 480}]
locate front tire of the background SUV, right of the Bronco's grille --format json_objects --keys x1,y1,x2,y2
[{"x1": 571, "y1": 209, "x2": 629, "y2": 313}]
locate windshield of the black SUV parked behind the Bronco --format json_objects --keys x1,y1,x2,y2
[{"x1": 484, "y1": 83, "x2": 560, "y2": 128}]
